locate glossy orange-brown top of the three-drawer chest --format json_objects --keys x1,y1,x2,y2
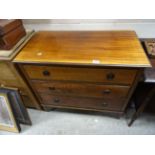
[{"x1": 14, "y1": 31, "x2": 150, "y2": 67}]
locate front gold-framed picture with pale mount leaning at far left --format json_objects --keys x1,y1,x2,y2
[{"x1": 0, "y1": 92, "x2": 21, "y2": 133}]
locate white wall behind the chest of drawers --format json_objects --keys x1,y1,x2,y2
[{"x1": 23, "y1": 19, "x2": 155, "y2": 38}]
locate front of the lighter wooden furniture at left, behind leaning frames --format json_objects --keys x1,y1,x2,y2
[{"x1": 0, "y1": 60, "x2": 40, "y2": 109}]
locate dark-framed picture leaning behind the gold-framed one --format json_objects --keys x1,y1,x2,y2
[{"x1": 0, "y1": 87, "x2": 32, "y2": 125}]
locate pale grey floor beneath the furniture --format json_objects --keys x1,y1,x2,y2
[{"x1": 0, "y1": 109, "x2": 155, "y2": 135}]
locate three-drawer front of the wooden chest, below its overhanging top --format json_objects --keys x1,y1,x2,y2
[{"x1": 18, "y1": 63, "x2": 139, "y2": 114}]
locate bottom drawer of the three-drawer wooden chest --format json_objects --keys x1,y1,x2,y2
[{"x1": 40, "y1": 94, "x2": 124, "y2": 111}]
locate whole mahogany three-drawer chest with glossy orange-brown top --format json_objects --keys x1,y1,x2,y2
[{"x1": 14, "y1": 31, "x2": 150, "y2": 114}]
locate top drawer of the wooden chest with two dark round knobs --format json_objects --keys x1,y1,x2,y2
[{"x1": 23, "y1": 65, "x2": 137, "y2": 84}]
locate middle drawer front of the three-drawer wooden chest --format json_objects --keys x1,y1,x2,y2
[{"x1": 32, "y1": 81, "x2": 130, "y2": 98}]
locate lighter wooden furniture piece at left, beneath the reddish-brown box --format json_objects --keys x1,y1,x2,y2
[{"x1": 0, "y1": 31, "x2": 40, "y2": 109}]
